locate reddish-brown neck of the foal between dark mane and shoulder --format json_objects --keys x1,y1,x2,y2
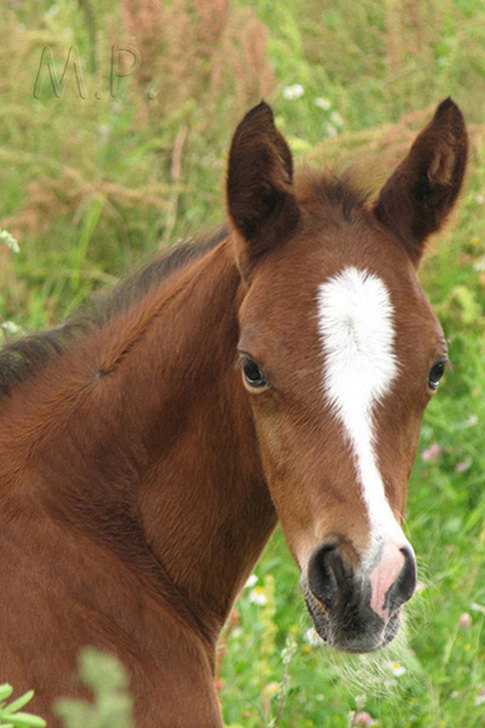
[{"x1": 5, "y1": 241, "x2": 275, "y2": 638}]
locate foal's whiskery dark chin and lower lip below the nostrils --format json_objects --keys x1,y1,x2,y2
[{"x1": 304, "y1": 589, "x2": 400, "y2": 654}]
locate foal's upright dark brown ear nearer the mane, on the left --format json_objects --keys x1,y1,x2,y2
[{"x1": 226, "y1": 101, "x2": 299, "y2": 272}]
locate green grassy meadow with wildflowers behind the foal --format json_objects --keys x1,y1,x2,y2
[{"x1": 0, "y1": 0, "x2": 485, "y2": 728}]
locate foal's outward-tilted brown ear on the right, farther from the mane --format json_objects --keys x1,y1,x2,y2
[{"x1": 374, "y1": 98, "x2": 468, "y2": 267}]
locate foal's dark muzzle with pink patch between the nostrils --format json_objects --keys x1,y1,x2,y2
[{"x1": 301, "y1": 541, "x2": 416, "y2": 653}]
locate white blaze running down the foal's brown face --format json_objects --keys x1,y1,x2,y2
[{"x1": 318, "y1": 267, "x2": 407, "y2": 559}]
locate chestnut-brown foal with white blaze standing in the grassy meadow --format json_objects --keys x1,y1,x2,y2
[{"x1": 0, "y1": 99, "x2": 467, "y2": 728}]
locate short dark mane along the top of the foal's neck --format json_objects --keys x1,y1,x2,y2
[{"x1": 0, "y1": 228, "x2": 227, "y2": 398}]
